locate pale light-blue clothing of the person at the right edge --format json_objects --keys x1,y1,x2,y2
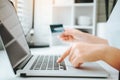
[{"x1": 105, "y1": 0, "x2": 120, "y2": 48}]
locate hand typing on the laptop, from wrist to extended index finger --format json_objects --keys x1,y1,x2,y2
[{"x1": 57, "y1": 42, "x2": 107, "y2": 67}]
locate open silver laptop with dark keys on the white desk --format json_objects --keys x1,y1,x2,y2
[{"x1": 0, "y1": 0, "x2": 109, "y2": 78}]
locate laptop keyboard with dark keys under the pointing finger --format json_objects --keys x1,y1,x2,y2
[{"x1": 30, "y1": 55, "x2": 66, "y2": 70}]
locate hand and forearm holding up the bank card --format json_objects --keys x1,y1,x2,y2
[{"x1": 60, "y1": 29, "x2": 108, "y2": 44}]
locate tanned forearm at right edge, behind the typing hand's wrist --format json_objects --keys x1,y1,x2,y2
[{"x1": 103, "y1": 47, "x2": 120, "y2": 70}]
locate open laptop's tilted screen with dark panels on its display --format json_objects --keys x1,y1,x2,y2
[{"x1": 0, "y1": 0, "x2": 30, "y2": 68}]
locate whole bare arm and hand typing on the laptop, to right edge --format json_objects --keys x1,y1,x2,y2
[{"x1": 57, "y1": 42, "x2": 120, "y2": 70}]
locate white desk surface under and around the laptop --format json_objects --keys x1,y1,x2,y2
[{"x1": 0, "y1": 46, "x2": 118, "y2": 80}]
